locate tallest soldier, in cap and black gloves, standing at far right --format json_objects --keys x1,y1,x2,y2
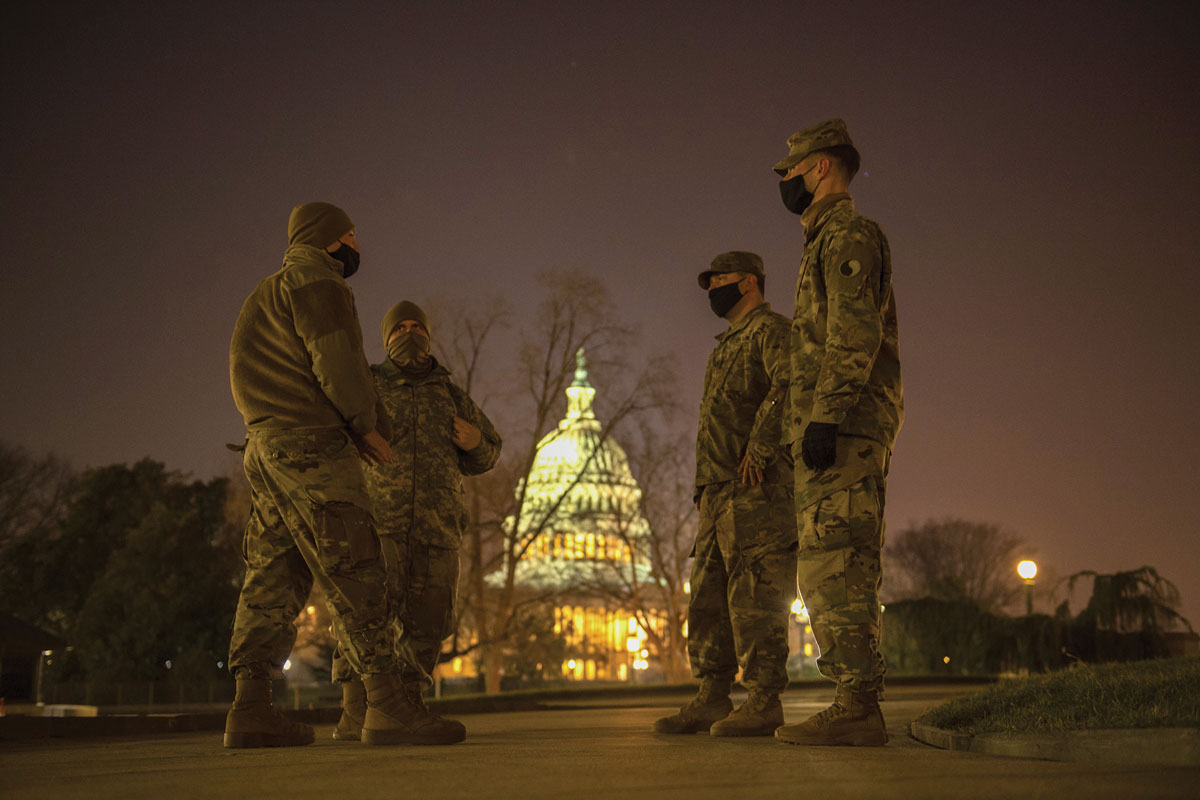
[{"x1": 775, "y1": 120, "x2": 904, "y2": 745}]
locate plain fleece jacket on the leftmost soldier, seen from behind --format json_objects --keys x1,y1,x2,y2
[{"x1": 229, "y1": 245, "x2": 388, "y2": 435}]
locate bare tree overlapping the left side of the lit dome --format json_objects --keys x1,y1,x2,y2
[{"x1": 446, "y1": 272, "x2": 686, "y2": 691}]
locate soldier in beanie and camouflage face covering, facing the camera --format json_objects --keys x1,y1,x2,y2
[{"x1": 332, "y1": 301, "x2": 500, "y2": 739}]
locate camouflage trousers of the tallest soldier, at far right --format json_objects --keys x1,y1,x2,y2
[{"x1": 797, "y1": 474, "x2": 887, "y2": 690}]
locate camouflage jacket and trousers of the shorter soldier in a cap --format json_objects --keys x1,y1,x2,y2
[{"x1": 688, "y1": 303, "x2": 796, "y2": 693}]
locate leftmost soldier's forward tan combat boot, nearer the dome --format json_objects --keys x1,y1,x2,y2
[{"x1": 362, "y1": 674, "x2": 467, "y2": 745}]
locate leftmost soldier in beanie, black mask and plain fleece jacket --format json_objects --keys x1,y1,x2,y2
[{"x1": 224, "y1": 203, "x2": 462, "y2": 747}]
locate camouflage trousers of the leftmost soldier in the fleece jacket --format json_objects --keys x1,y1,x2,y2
[{"x1": 229, "y1": 428, "x2": 397, "y2": 678}]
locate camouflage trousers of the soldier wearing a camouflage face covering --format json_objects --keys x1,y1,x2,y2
[{"x1": 332, "y1": 530, "x2": 458, "y2": 692}]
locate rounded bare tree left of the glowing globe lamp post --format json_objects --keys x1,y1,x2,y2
[{"x1": 884, "y1": 518, "x2": 1031, "y2": 610}]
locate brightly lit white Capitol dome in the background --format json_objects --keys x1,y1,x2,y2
[{"x1": 516, "y1": 348, "x2": 650, "y2": 589}]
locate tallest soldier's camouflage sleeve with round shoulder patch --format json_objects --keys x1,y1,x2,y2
[{"x1": 811, "y1": 229, "x2": 883, "y2": 425}]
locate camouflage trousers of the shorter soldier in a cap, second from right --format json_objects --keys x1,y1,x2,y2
[{"x1": 688, "y1": 481, "x2": 796, "y2": 692}]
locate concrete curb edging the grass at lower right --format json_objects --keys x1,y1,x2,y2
[{"x1": 908, "y1": 722, "x2": 1200, "y2": 766}]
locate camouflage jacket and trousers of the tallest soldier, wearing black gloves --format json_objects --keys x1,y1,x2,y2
[{"x1": 788, "y1": 185, "x2": 904, "y2": 690}]
